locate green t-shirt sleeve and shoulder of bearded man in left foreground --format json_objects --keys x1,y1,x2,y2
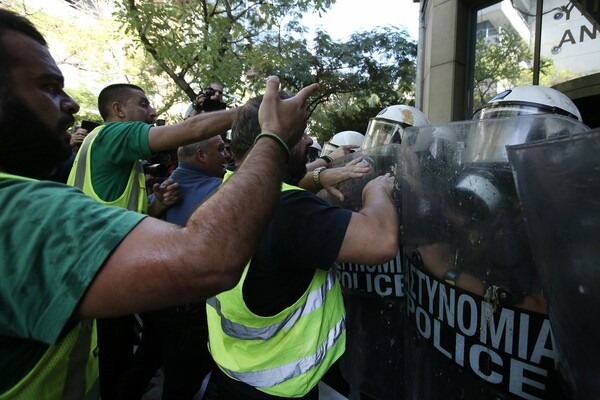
[{"x1": 0, "y1": 176, "x2": 144, "y2": 393}]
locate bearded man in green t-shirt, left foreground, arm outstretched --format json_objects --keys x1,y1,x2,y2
[{"x1": 0, "y1": 9, "x2": 318, "y2": 399}]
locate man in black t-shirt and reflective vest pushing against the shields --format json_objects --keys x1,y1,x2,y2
[{"x1": 206, "y1": 94, "x2": 398, "y2": 400}]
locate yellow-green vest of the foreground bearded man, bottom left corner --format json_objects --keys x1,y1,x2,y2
[{"x1": 0, "y1": 173, "x2": 100, "y2": 400}]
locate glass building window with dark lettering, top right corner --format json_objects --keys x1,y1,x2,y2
[{"x1": 470, "y1": 0, "x2": 600, "y2": 113}]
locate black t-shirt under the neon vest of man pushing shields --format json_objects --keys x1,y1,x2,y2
[{"x1": 244, "y1": 190, "x2": 352, "y2": 316}]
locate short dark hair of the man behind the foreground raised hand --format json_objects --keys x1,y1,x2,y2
[{"x1": 231, "y1": 91, "x2": 292, "y2": 160}]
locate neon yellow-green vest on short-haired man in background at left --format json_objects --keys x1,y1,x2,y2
[{"x1": 67, "y1": 125, "x2": 148, "y2": 214}]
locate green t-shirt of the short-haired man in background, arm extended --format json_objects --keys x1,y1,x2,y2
[{"x1": 91, "y1": 122, "x2": 152, "y2": 201}]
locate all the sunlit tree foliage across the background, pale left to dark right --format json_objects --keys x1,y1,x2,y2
[{"x1": 8, "y1": 0, "x2": 416, "y2": 141}]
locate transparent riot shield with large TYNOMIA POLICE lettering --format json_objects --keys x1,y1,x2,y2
[{"x1": 401, "y1": 115, "x2": 585, "y2": 400}]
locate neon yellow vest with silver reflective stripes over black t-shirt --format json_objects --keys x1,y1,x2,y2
[{"x1": 206, "y1": 171, "x2": 346, "y2": 397}]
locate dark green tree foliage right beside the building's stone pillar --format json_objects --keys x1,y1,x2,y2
[{"x1": 292, "y1": 27, "x2": 417, "y2": 141}]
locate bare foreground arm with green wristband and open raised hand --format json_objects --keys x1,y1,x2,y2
[{"x1": 75, "y1": 77, "x2": 318, "y2": 318}]
